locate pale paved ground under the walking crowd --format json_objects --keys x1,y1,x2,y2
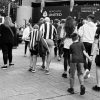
[{"x1": 0, "y1": 44, "x2": 100, "y2": 100}]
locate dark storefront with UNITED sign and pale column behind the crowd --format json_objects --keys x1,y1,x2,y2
[{"x1": 17, "y1": 0, "x2": 100, "y2": 25}]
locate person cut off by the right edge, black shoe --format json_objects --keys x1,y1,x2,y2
[{"x1": 91, "y1": 25, "x2": 100, "y2": 92}]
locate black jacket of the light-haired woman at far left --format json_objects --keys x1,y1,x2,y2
[{"x1": 0, "y1": 24, "x2": 14, "y2": 45}]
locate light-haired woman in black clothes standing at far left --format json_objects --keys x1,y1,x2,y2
[{"x1": 0, "y1": 16, "x2": 14, "y2": 69}]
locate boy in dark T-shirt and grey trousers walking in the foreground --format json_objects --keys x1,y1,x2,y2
[{"x1": 67, "y1": 33, "x2": 91, "y2": 95}]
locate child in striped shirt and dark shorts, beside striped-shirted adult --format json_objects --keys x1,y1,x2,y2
[{"x1": 29, "y1": 24, "x2": 39, "y2": 73}]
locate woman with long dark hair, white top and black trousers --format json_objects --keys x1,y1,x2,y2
[{"x1": 62, "y1": 16, "x2": 76, "y2": 78}]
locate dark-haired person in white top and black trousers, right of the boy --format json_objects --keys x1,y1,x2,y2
[{"x1": 78, "y1": 14, "x2": 97, "y2": 79}]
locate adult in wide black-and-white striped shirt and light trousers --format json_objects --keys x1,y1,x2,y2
[{"x1": 40, "y1": 17, "x2": 57, "y2": 74}]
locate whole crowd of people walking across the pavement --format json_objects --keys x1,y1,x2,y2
[{"x1": 0, "y1": 14, "x2": 100, "y2": 95}]
